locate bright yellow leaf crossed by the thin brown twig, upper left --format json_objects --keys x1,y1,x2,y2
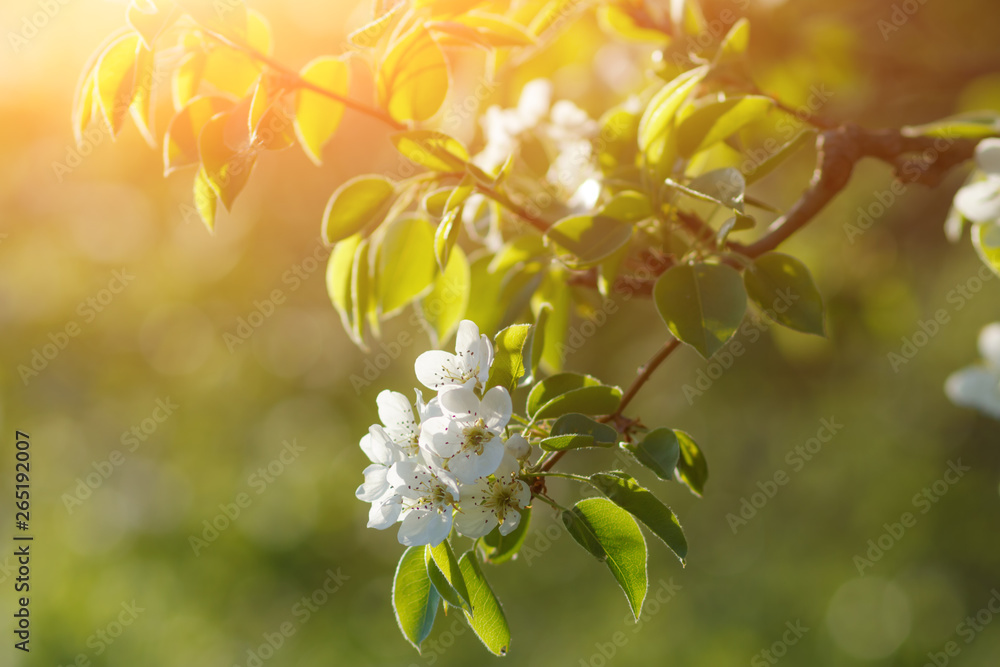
[{"x1": 294, "y1": 56, "x2": 350, "y2": 167}]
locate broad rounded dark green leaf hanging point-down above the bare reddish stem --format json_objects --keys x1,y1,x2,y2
[{"x1": 653, "y1": 263, "x2": 747, "y2": 359}]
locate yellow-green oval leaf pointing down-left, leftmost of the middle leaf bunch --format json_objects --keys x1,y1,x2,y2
[{"x1": 323, "y1": 175, "x2": 396, "y2": 244}]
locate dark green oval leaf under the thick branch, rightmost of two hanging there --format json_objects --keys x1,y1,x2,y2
[{"x1": 743, "y1": 252, "x2": 825, "y2": 336}]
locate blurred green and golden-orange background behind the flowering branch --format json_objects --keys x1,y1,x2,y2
[{"x1": 0, "y1": 0, "x2": 1000, "y2": 667}]
